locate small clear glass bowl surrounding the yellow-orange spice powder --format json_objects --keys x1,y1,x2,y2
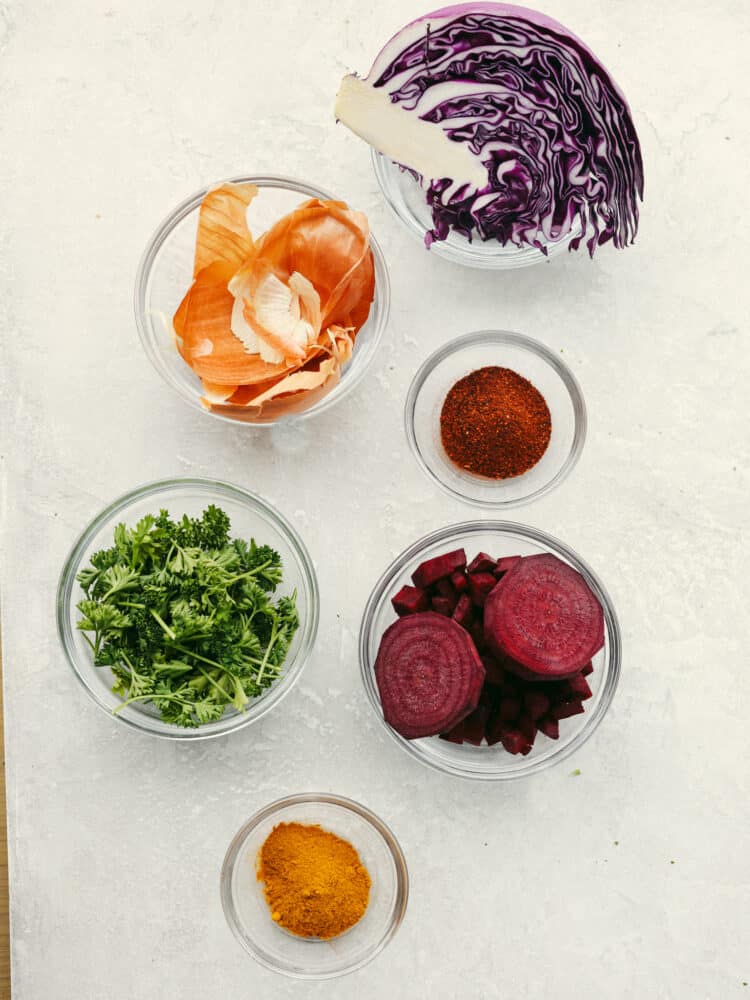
[{"x1": 221, "y1": 793, "x2": 409, "y2": 979}]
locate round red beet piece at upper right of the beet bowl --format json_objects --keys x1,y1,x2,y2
[{"x1": 484, "y1": 553, "x2": 604, "y2": 680}]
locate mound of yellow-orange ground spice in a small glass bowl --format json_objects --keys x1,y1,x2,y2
[{"x1": 258, "y1": 823, "x2": 371, "y2": 938}]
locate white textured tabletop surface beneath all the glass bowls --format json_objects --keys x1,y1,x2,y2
[{"x1": 0, "y1": 0, "x2": 750, "y2": 1000}]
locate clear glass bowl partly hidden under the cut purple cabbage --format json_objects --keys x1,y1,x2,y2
[{"x1": 372, "y1": 149, "x2": 580, "y2": 271}]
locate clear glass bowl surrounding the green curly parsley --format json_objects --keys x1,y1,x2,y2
[{"x1": 57, "y1": 479, "x2": 319, "y2": 740}]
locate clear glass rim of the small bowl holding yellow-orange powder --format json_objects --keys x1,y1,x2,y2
[{"x1": 220, "y1": 792, "x2": 409, "y2": 980}]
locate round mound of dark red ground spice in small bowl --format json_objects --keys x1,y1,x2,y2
[{"x1": 440, "y1": 365, "x2": 552, "y2": 479}]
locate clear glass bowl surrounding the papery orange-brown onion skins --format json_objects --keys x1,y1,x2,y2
[{"x1": 135, "y1": 175, "x2": 390, "y2": 426}]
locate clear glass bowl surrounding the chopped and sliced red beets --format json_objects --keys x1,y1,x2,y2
[{"x1": 359, "y1": 521, "x2": 622, "y2": 781}]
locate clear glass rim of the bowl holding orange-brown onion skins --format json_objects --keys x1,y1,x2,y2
[{"x1": 133, "y1": 174, "x2": 391, "y2": 428}]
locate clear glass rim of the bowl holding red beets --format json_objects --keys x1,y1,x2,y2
[{"x1": 359, "y1": 521, "x2": 622, "y2": 781}]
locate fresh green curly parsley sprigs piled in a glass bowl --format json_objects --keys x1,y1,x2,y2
[{"x1": 78, "y1": 505, "x2": 299, "y2": 728}]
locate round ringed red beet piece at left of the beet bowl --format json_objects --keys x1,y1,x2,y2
[{"x1": 375, "y1": 611, "x2": 484, "y2": 740}]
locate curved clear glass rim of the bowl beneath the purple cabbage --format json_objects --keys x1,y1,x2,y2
[{"x1": 370, "y1": 147, "x2": 576, "y2": 271}]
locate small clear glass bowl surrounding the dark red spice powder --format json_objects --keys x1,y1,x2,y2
[{"x1": 404, "y1": 330, "x2": 586, "y2": 509}]
